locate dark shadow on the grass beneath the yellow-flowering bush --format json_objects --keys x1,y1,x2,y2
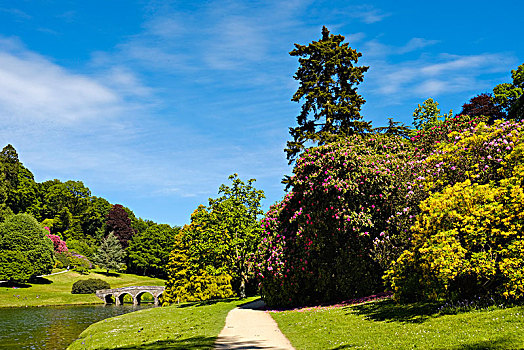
[{"x1": 345, "y1": 299, "x2": 439, "y2": 323}]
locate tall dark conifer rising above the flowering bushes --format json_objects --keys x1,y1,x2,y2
[{"x1": 285, "y1": 27, "x2": 370, "y2": 164}]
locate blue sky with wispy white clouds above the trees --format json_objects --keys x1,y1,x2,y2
[{"x1": 0, "y1": 0, "x2": 524, "y2": 225}]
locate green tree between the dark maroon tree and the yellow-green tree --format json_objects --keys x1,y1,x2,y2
[{"x1": 127, "y1": 224, "x2": 180, "y2": 278}]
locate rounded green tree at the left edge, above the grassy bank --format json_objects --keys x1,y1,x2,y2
[{"x1": 0, "y1": 214, "x2": 53, "y2": 282}]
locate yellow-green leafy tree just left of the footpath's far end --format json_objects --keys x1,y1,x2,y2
[{"x1": 183, "y1": 174, "x2": 264, "y2": 297}]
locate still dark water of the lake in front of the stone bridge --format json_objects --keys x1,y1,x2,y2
[{"x1": 0, "y1": 305, "x2": 153, "y2": 350}]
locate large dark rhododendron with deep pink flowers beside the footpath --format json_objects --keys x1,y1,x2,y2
[{"x1": 255, "y1": 135, "x2": 413, "y2": 306}]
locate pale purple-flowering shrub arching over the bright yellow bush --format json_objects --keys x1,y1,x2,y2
[{"x1": 374, "y1": 116, "x2": 522, "y2": 268}]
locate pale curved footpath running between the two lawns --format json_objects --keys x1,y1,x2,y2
[{"x1": 215, "y1": 300, "x2": 294, "y2": 350}]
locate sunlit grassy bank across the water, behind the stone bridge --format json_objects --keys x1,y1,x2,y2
[{"x1": 0, "y1": 270, "x2": 164, "y2": 307}]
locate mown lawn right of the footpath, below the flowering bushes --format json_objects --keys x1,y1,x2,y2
[{"x1": 271, "y1": 299, "x2": 524, "y2": 350}]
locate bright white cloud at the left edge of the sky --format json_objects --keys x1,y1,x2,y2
[{"x1": 0, "y1": 39, "x2": 131, "y2": 124}]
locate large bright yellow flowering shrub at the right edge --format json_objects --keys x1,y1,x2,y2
[{"x1": 385, "y1": 142, "x2": 524, "y2": 300}]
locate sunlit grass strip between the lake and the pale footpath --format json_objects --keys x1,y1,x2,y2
[{"x1": 68, "y1": 298, "x2": 257, "y2": 350}]
